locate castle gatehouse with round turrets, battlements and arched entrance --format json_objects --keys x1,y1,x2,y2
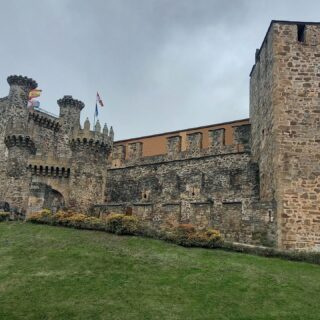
[{"x1": 0, "y1": 76, "x2": 113, "y2": 214}]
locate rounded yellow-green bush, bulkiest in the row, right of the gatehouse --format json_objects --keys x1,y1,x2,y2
[{"x1": 106, "y1": 213, "x2": 139, "y2": 234}]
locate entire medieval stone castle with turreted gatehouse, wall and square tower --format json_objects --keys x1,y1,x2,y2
[{"x1": 0, "y1": 21, "x2": 320, "y2": 251}]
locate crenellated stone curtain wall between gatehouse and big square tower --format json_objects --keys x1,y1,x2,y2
[{"x1": 95, "y1": 125, "x2": 275, "y2": 245}]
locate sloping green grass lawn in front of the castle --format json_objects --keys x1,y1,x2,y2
[{"x1": 0, "y1": 222, "x2": 320, "y2": 320}]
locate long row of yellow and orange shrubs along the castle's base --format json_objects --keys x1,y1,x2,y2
[{"x1": 25, "y1": 209, "x2": 320, "y2": 264}]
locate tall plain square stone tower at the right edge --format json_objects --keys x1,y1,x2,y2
[{"x1": 250, "y1": 21, "x2": 320, "y2": 250}]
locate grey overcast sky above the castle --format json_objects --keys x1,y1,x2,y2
[{"x1": 0, "y1": 0, "x2": 320, "y2": 140}]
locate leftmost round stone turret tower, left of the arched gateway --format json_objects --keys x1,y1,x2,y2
[{"x1": 0, "y1": 76, "x2": 37, "y2": 211}]
